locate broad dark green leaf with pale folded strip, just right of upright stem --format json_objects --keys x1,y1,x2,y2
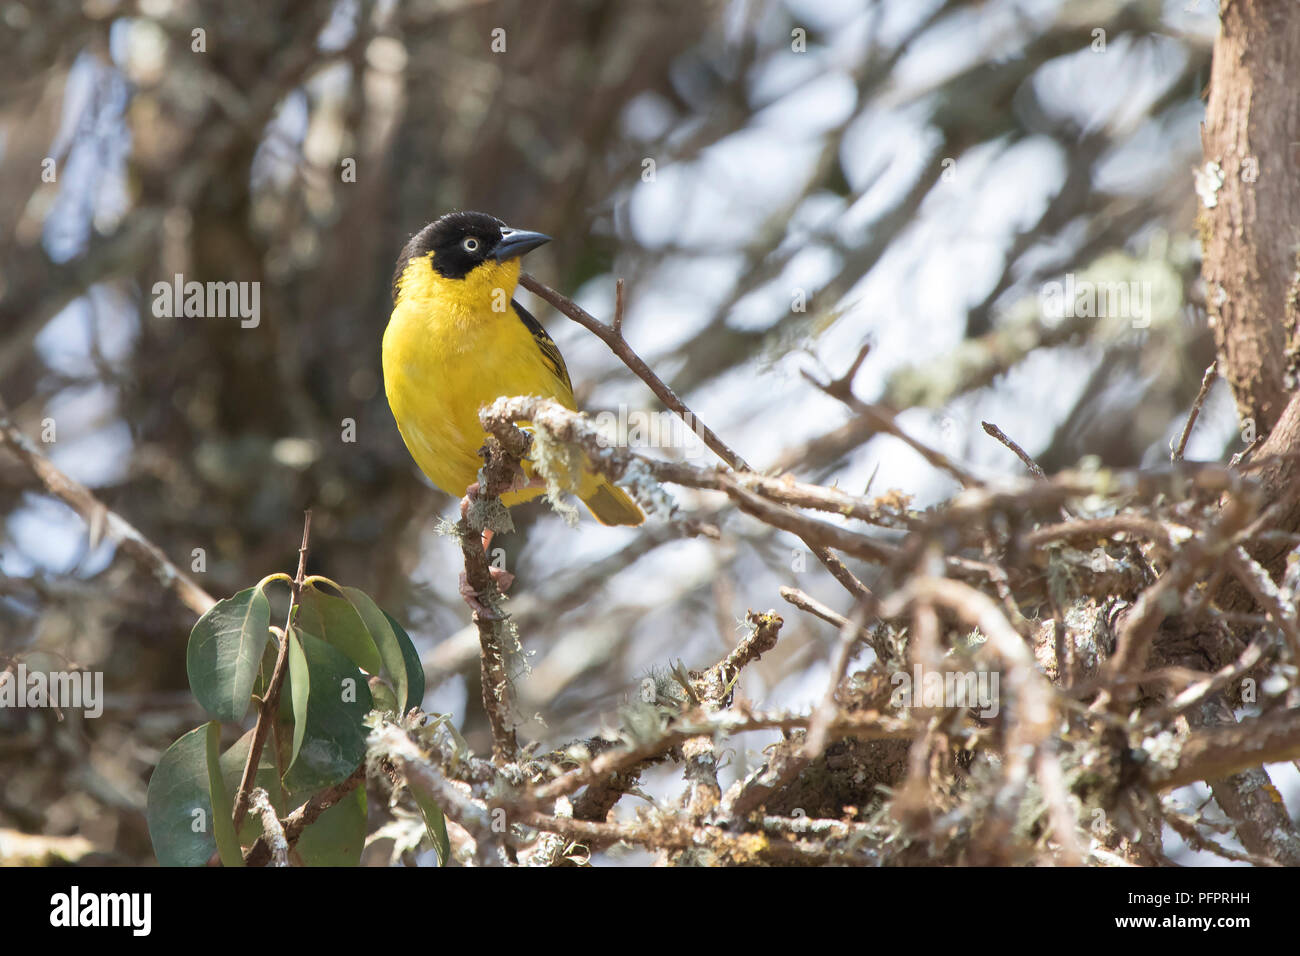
[{"x1": 285, "y1": 628, "x2": 372, "y2": 791}]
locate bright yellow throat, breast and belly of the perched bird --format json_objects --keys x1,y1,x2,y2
[{"x1": 384, "y1": 256, "x2": 575, "y2": 503}]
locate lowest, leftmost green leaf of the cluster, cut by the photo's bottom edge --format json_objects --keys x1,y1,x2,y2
[{"x1": 144, "y1": 722, "x2": 217, "y2": 866}]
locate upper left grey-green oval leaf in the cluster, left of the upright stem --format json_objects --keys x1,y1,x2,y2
[{"x1": 186, "y1": 588, "x2": 270, "y2": 721}]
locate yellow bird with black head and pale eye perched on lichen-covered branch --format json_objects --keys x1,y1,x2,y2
[{"x1": 384, "y1": 212, "x2": 644, "y2": 524}]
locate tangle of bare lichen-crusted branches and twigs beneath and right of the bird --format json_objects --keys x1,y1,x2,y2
[{"x1": 372, "y1": 280, "x2": 1300, "y2": 865}]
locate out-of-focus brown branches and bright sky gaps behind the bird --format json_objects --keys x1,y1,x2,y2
[{"x1": 0, "y1": 0, "x2": 1240, "y2": 862}]
